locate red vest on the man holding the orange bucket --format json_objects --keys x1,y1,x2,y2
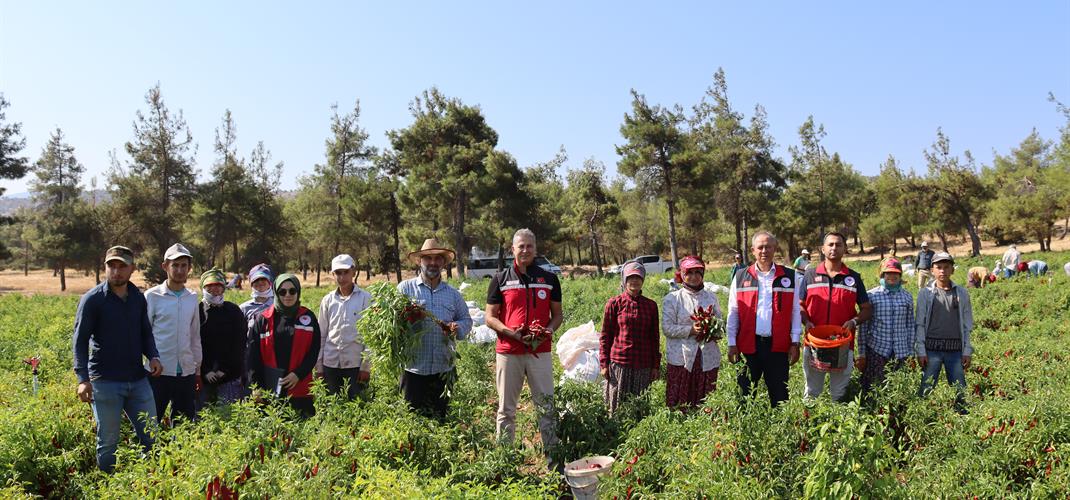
[{"x1": 801, "y1": 262, "x2": 862, "y2": 349}]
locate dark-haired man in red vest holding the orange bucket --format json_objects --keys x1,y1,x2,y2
[{"x1": 799, "y1": 232, "x2": 873, "y2": 400}]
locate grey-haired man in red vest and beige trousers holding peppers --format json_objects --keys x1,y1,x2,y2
[{"x1": 486, "y1": 229, "x2": 562, "y2": 451}]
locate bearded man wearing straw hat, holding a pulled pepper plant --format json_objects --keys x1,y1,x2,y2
[{"x1": 398, "y1": 238, "x2": 472, "y2": 422}]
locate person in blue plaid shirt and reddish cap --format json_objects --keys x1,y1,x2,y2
[{"x1": 855, "y1": 258, "x2": 915, "y2": 394}]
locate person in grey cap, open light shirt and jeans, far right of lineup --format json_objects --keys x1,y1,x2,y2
[{"x1": 914, "y1": 252, "x2": 974, "y2": 409}]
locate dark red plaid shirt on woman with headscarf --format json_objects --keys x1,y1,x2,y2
[{"x1": 598, "y1": 292, "x2": 661, "y2": 368}]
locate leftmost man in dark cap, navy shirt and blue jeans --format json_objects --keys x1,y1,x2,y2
[{"x1": 73, "y1": 246, "x2": 163, "y2": 472}]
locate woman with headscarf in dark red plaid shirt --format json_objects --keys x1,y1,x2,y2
[{"x1": 598, "y1": 261, "x2": 661, "y2": 414}]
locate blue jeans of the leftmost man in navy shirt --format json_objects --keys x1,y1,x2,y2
[{"x1": 92, "y1": 378, "x2": 156, "y2": 472}]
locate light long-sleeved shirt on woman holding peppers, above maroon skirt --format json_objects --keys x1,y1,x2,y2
[{"x1": 661, "y1": 287, "x2": 723, "y2": 372}]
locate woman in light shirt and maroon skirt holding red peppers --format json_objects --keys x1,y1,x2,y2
[{"x1": 661, "y1": 256, "x2": 722, "y2": 407}]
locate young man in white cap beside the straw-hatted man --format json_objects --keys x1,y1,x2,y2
[{"x1": 316, "y1": 254, "x2": 371, "y2": 399}]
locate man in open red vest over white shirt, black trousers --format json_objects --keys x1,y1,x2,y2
[{"x1": 725, "y1": 231, "x2": 803, "y2": 406}]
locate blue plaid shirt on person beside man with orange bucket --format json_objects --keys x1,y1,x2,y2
[{"x1": 857, "y1": 286, "x2": 915, "y2": 359}]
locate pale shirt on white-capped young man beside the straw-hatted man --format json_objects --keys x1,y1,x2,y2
[{"x1": 316, "y1": 285, "x2": 371, "y2": 373}]
